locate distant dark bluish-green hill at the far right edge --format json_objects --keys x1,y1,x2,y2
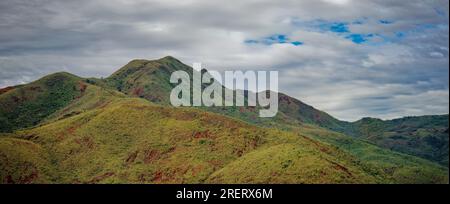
[{"x1": 348, "y1": 115, "x2": 449, "y2": 166}]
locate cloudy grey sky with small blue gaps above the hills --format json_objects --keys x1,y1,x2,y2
[{"x1": 0, "y1": 0, "x2": 449, "y2": 121}]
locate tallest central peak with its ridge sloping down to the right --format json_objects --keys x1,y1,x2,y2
[{"x1": 98, "y1": 56, "x2": 348, "y2": 128}]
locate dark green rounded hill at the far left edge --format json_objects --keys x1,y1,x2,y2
[{"x1": 0, "y1": 73, "x2": 85, "y2": 132}]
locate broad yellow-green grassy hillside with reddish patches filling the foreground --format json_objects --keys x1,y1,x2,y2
[{"x1": 0, "y1": 58, "x2": 448, "y2": 183}]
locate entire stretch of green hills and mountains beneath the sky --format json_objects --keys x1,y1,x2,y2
[{"x1": 0, "y1": 57, "x2": 449, "y2": 183}]
